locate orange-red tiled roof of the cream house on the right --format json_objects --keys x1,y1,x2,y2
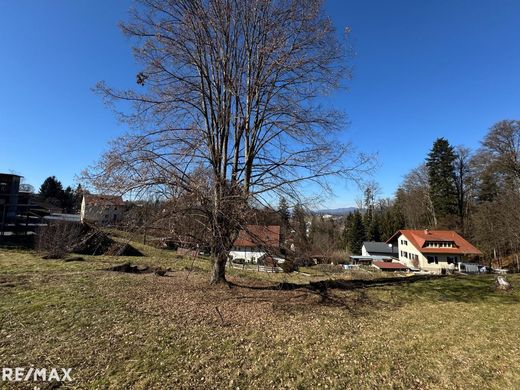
[{"x1": 387, "y1": 230, "x2": 482, "y2": 255}]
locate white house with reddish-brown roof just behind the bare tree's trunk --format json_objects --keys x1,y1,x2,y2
[{"x1": 229, "y1": 225, "x2": 284, "y2": 263}]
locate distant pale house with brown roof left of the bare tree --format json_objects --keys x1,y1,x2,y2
[{"x1": 80, "y1": 194, "x2": 125, "y2": 225}]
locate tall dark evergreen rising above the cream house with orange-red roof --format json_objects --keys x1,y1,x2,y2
[{"x1": 426, "y1": 138, "x2": 457, "y2": 224}]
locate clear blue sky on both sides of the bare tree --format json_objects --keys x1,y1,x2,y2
[{"x1": 0, "y1": 0, "x2": 520, "y2": 207}]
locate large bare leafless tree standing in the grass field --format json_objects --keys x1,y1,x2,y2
[{"x1": 86, "y1": 0, "x2": 369, "y2": 283}]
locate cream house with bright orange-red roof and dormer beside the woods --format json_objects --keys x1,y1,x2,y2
[{"x1": 387, "y1": 229, "x2": 482, "y2": 273}]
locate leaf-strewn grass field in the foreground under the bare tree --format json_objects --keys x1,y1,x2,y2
[{"x1": 0, "y1": 247, "x2": 520, "y2": 389}]
